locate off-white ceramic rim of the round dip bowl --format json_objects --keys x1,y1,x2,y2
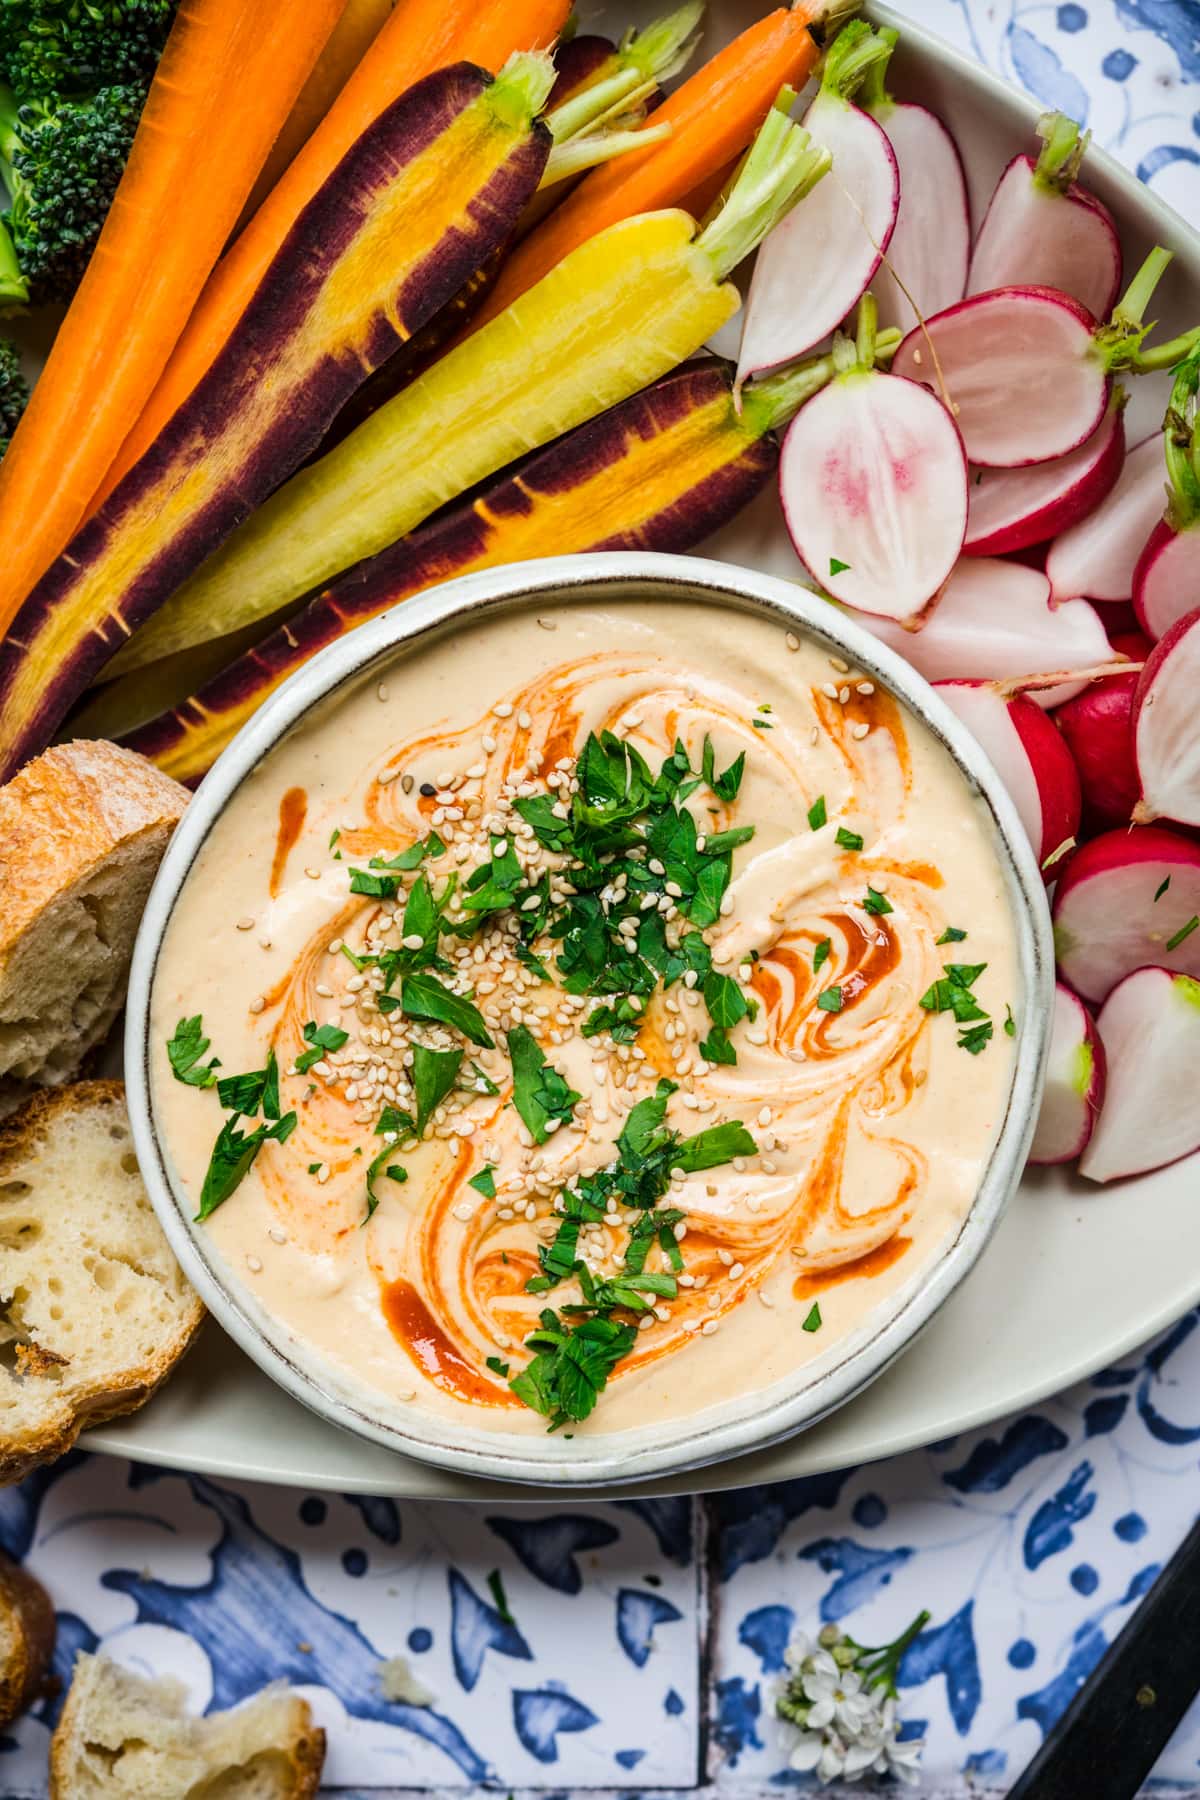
[{"x1": 124, "y1": 553, "x2": 1054, "y2": 1489}]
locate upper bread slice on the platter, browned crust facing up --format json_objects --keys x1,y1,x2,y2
[{"x1": 0, "y1": 742, "x2": 187, "y2": 1111}]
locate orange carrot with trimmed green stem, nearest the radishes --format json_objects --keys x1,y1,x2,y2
[{"x1": 464, "y1": 0, "x2": 828, "y2": 335}]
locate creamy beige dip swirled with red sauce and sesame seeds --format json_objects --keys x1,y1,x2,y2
[{"x1": 145, "y1": 601, "x2": 1018, "y2": 1433}]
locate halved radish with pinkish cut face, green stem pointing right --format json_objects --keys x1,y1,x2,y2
[{"x1": 892, "y1": 250, "x2": 1200, "y2": 468}]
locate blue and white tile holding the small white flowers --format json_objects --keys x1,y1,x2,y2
[{"x1": 711, "y1": 1314, "x2": 1200, "y2": 1795}]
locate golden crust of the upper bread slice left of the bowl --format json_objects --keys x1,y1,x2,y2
[{"x1": 0, "y1": 738, "x2": 191, "y2": 968}]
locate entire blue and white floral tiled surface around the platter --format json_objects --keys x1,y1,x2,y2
[{"x1": 0, "y1": 0, "x2": 1200, "y2": 1800}]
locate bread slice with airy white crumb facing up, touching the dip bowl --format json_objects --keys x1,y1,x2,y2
[{"x1": 0, "y1": 1082, "x2": 203, "y2": 1481}]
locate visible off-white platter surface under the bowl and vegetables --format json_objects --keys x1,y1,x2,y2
[{"x1": 85, "y1": 0, "x2": 1200, "y2": 1501}]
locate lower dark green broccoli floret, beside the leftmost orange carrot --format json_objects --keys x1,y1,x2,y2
[{"x1": 0, "y1": 86, "x2": 146, "y2": 304}]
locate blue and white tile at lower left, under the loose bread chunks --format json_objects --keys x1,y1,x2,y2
[{"x1": 0, "y1": 1456, "x2": 700, "y2": 1796}]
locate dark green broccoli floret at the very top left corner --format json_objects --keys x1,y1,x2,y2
[{"x1": 0, "y1": 0, "x2": 176, "y2": 101}]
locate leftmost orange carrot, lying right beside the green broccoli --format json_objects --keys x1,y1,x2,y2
[{"x1": 0, "y1": 0, "x2": 340, "y2": 632}]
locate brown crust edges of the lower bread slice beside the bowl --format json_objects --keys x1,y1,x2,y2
[{"x1": 0, "y1": 1082, "x2": 205, "y2": 1487}]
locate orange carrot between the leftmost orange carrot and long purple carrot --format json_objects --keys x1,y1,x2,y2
[{"x1": 90, "y1": 0, "x2": 570, "y2": 511}]
